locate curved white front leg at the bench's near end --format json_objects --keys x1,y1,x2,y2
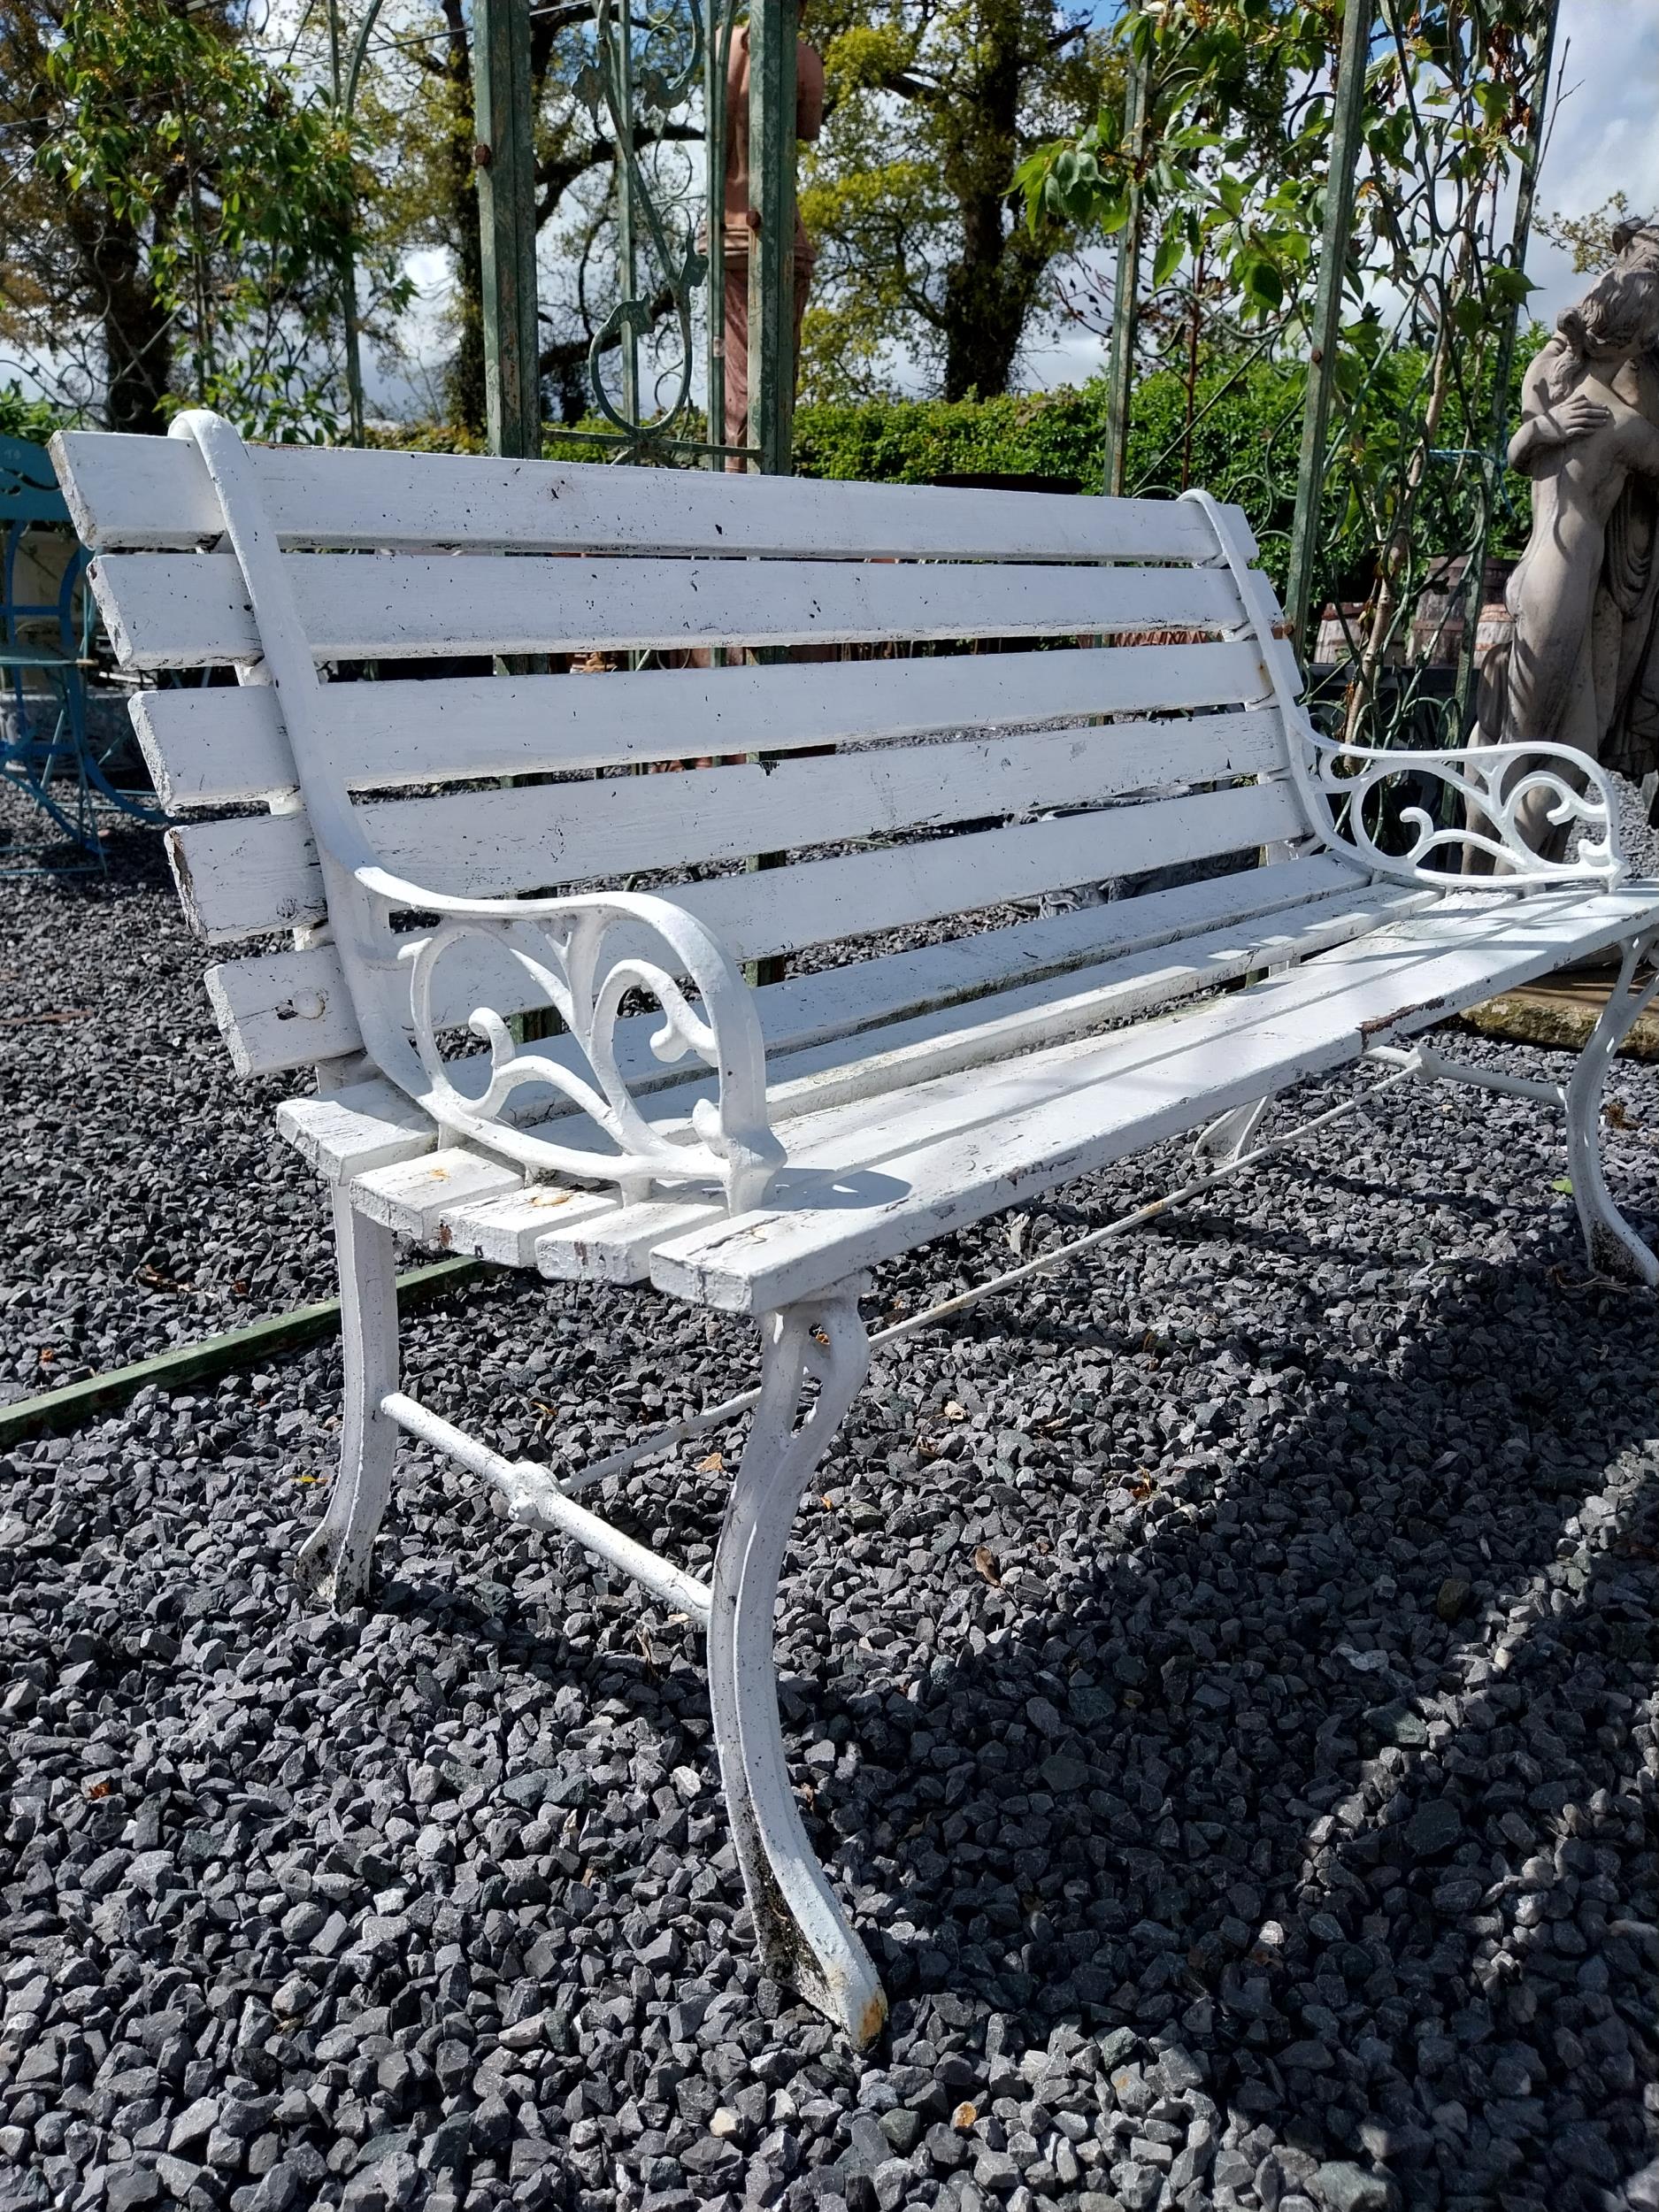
[{"x1": 708, "y1": 1290, "x2": 887, "y2": 2047}]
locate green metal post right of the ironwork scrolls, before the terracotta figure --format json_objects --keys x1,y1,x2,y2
[{"x1": 750, "y1": 0, "x2": 799, "y2": 476}]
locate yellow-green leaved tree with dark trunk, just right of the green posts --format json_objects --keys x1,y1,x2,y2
[{"x1": 801, "y1": 0, "x2": 1122, "y2": 398}]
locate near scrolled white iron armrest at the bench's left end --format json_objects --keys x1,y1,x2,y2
[{"x1": 354, "y1": 867, "x2": 783, "y2": 1215}]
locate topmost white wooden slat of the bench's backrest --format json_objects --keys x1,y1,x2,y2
[{"x1": 53, "y1": 432, "x2": 1243, "y2": 560}]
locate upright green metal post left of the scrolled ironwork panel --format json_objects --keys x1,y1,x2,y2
[{"x1": 473, "y1": 0, "x2": 542, "y2": 460}]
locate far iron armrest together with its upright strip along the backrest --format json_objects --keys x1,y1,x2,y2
[{"x1": 1181, "y1": 491, "x2": 1631, "y2": 894}]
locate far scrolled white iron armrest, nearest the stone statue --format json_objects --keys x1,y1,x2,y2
[{"x1": 1292, "y1": 717, "x2": 1628, "y2": 892}]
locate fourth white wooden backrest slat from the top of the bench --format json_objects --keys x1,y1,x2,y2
[{"x1": 173, "y1": 708, "x2": 1286, "y2": 929}]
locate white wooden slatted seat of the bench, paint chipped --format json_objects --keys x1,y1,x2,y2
[{"x1": 327, "y1": 887, "x2": 1653, "y2": 1312}]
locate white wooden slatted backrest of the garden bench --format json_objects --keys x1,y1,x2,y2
[{"x1": 58, "y1": 434, "x2": 1305, "y2": 1088}]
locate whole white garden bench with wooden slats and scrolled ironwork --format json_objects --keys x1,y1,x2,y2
[{"x1": 53, "y1": 414, "x2": 1659, "y2": 2042}]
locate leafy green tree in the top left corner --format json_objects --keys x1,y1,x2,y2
[{"x1": 0, "y1": 0, "x2": 382, "y2": 438}]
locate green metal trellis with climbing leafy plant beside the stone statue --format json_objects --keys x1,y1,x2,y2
[{"x1": 1104, "y1": 0, "x2": 1557, "y2": 741}]
